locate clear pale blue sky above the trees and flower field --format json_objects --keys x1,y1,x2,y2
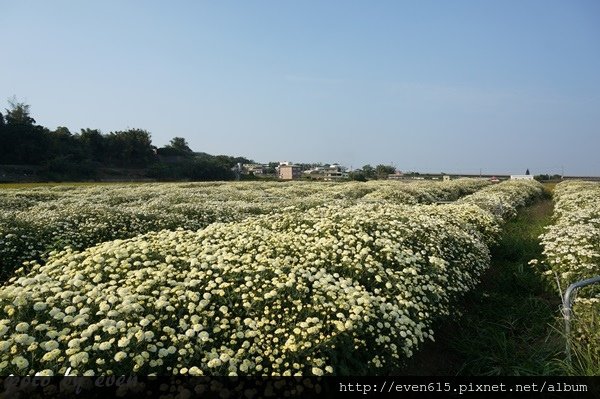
[{"x1": 0, "y1": 0, "x2": 600, "y2": 175}]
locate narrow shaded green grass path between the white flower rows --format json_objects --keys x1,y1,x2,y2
[{"x1": 398, "y1": 199, "x2": 563, "y2": 375}]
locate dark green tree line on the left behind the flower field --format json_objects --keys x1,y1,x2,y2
[{"x1": 0, "y1": 100, "x2": 252, "y2": 180}]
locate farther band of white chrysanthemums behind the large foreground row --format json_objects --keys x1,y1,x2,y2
[{"x1": 0, "y1": 179, "x2": 489, "y2": 281}]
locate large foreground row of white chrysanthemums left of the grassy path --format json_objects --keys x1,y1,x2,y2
[{"x1": 0, "y1": 182, "x2": 542, "y2": 375}]
